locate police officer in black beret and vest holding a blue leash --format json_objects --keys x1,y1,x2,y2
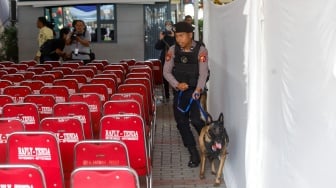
[{"x1": 163, "y1": 22, "x2": 208, "y2": 168}]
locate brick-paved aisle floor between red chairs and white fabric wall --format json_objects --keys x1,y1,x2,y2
[{"x1": 150, "y1": 95, "x2": 225, "y2": 188}]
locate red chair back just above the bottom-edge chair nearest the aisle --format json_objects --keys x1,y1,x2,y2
[{"x1": 74, "y1": 140, "x2": 130, "y2": 168}]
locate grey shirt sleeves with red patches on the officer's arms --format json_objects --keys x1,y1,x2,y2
[{"x1": 163, "y1": 41, "x2": 209, "y2": 91}]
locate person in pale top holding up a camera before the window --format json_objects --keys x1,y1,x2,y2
[{"x1": 66, "y1": 20, "x2": 91, "y2": 64}]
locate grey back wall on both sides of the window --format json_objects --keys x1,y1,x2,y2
[{"x1": 18, "y1": 4, "x2": 144, "y2": 62}]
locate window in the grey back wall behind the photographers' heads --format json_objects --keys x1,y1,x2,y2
[{"x1": 45, "y1": 4, "x2": 116, "y2": 42}]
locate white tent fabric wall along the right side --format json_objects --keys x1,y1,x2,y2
[{"x1": 204, "y1": 0, "x2": 336, "y2": 188}]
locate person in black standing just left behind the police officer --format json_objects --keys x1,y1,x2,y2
[{"x1": 155, "y1": 20, "x2": 175, "y2": 99}]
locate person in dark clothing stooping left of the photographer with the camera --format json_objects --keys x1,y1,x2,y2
[{"x1": 40, "y1": 28, "x2": 70, "y2": 63}]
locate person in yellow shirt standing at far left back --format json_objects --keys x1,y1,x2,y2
[{"x1": 34, "y1": 16, "x2": 54, "y2": 62}]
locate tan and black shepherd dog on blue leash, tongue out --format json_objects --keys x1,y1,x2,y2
[{"x1": 199, "y1": 113, "x2": 229, "y2": 186}]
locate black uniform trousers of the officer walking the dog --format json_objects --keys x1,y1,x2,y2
[{"x1": 173, "y1": 89, "x2": 205, "y2": 148}]
